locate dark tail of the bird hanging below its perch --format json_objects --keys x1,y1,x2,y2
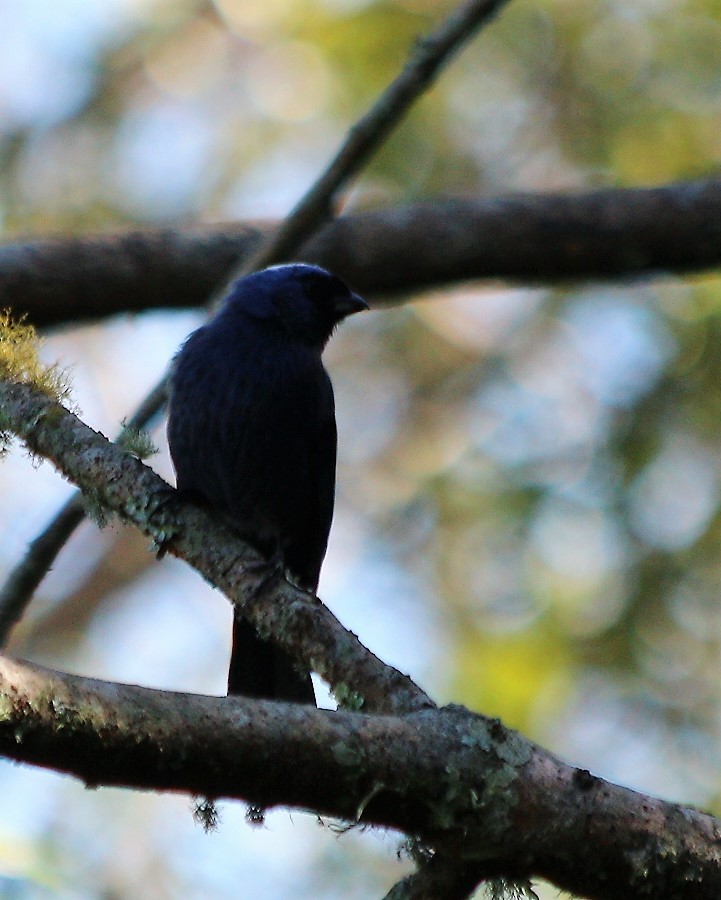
[{"x1": 228, "y1": 614, "x2": 315, "y2": 706}]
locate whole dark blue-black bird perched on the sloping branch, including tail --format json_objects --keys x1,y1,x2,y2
[{"x1": 167, "y1": 263, "x2": 368, "y2": 704}]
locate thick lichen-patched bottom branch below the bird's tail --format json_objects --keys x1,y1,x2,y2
[{"x1": 0, "y1": 657, "x2": 721, "y2": 900}]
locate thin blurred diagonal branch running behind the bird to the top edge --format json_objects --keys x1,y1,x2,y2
[{"x1": 0, "y1": 0, "x2": 507, "y2": 646}]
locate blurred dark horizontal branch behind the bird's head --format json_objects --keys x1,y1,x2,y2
[{"x1": 0, "y1": 178, "x2": 721, "y2": 326}]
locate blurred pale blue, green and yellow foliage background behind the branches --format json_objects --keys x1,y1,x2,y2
[{"x1": 0, "y1": 0, "x2": 721, "y2": 898}]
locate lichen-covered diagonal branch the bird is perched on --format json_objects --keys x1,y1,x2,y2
[{"x1": 0, "y1": 380, "x2": 433, "y2": 712}]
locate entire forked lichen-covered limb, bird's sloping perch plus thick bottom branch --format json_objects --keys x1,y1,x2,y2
[{"x1": 0, "y1": 382, "x2": 721, "y2": 898}]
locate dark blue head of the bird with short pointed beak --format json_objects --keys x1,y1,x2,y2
[{"x1": 225, "y1": 263, "x2": 368, "y2": 350}]
